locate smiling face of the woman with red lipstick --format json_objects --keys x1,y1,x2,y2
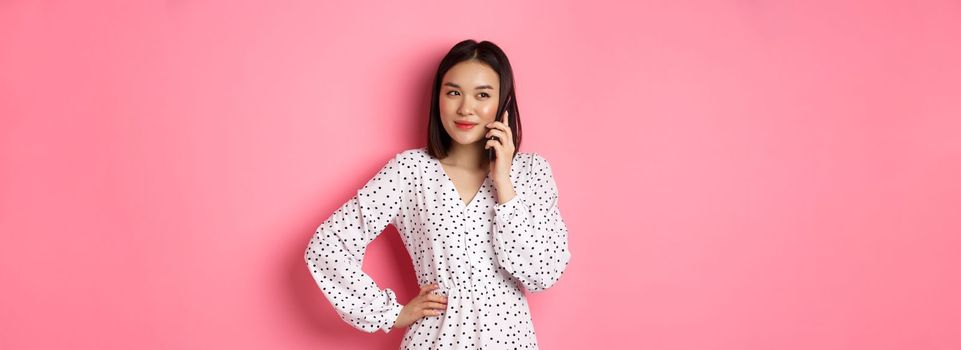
[{"x1": 438, "y1": 60, "x2": 500, "y2": 146}]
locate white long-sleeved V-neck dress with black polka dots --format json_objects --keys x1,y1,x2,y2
[{"x1": 304, "y1": 147, "x2": 570, "y2": 349}]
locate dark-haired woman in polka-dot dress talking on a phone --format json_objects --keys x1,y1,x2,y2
[{"x1": 304, "y1": 40, "x2": 571, "y2": 349}]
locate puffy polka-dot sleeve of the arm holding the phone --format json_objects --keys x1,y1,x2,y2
[{"x1": 493, "y1": 153, "x2": 571, "y2": 292}]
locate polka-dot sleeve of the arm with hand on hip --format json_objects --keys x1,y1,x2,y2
[{"x1": 304, "y1": 154, "x2": 403, "y2": 333}]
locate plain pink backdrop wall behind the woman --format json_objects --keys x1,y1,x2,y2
[{"x1": 0, "y1": 0, "x2": 961, "y2": 349}]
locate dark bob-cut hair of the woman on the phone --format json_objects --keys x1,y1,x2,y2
[{"x1": 427, "y1": 39, "x2": 521, "y2": 159}]
